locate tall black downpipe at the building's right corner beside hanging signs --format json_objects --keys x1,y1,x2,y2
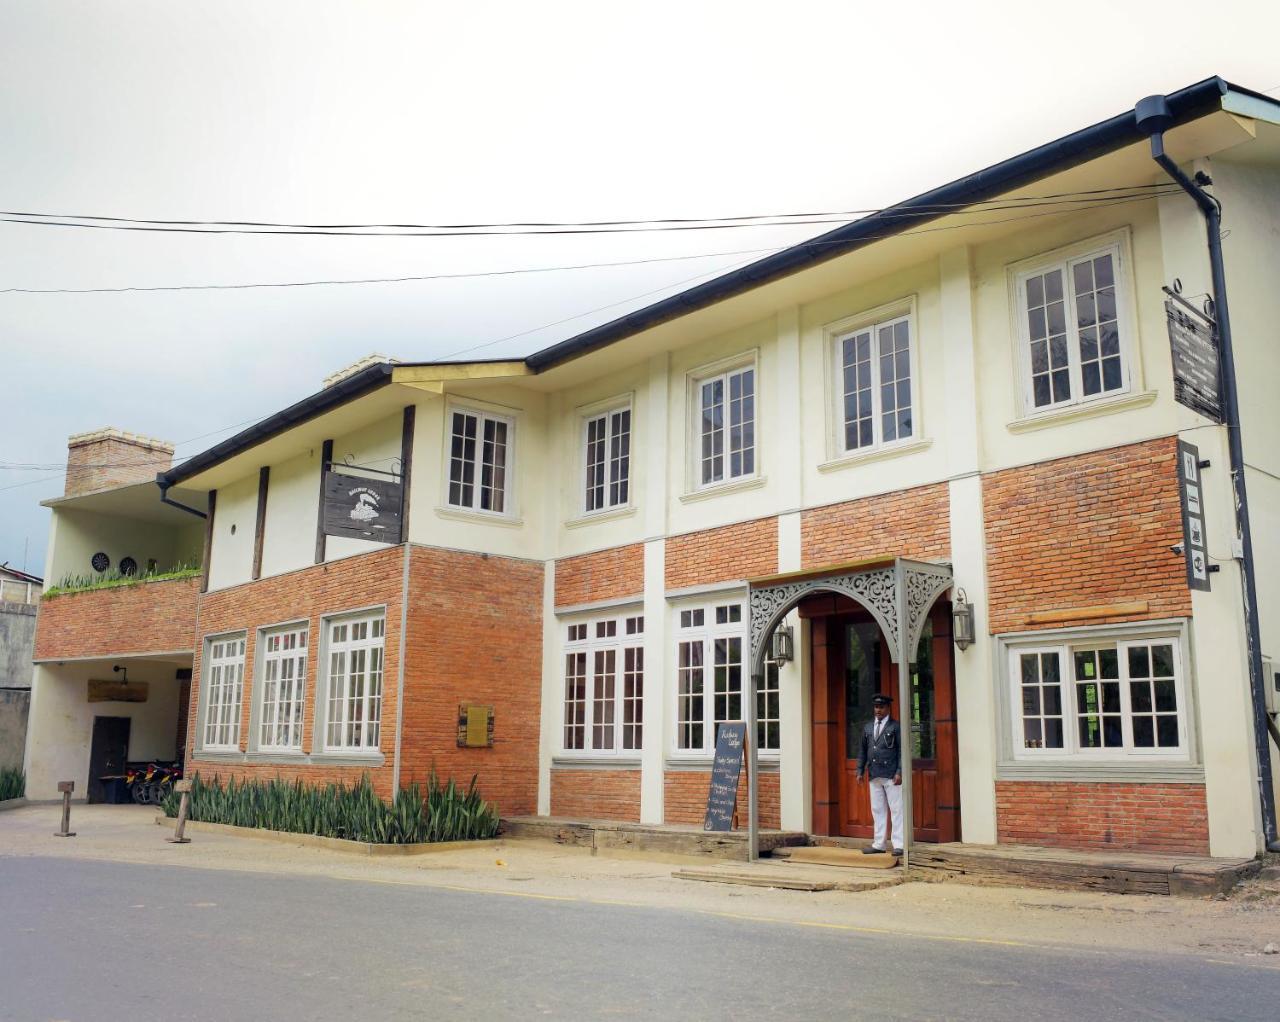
[{"x1": 1134, "y1": 96, "x2": 1280, "y2": 852}]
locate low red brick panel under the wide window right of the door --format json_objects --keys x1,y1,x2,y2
[{"x1": 996, "y1": 781, "x2": 1208, "y2": 856}]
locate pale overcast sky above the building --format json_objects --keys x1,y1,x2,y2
[{"x1": 0, "y1": 0, "x2": 1280, "y2": 572}]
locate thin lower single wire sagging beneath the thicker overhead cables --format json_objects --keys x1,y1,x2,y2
[{"x1": 0, "y1": 186, "x2": 1176, "y2": 295}]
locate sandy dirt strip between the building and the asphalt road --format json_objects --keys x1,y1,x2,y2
[{"x1": 0, "y1": 806, "x2": 1280, "y2": 972}]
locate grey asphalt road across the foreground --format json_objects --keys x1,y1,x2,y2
[{"x1": 0, "y1": 858, "x2": 1280, "y2": 1022}]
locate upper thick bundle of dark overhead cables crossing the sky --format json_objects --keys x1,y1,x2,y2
[{"x1": 0, "y1": 183, "x2": 1171, "y2": 238}]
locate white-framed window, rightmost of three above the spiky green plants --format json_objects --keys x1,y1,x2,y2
[{"x1": 320, "y1": 610, "x2": 387, "y2": 754}]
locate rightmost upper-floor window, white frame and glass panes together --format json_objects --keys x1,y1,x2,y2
[{"x1": 1016, "y1": 243, "x2": 1129, "y2": 411}]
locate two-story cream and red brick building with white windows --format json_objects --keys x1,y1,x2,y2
[{"x1": 27, "y1": 79, "x2": 1280, "y2": 856}]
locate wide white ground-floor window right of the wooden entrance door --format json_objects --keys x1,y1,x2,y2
[{"x1": 1009, "y1": 635, "x2": 1188, "y2": 758}]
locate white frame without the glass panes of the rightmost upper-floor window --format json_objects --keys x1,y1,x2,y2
[{"x1": 1009, "y1": 231, "x2": 1140, "y2": 419}]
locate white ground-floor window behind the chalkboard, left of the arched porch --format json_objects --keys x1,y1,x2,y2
[{"x1": 676, "y1": 601, "x2": 781, "y2": 753}]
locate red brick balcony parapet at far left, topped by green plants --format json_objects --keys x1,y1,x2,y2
[{"x1": 35, "y1": 579, "x2": 200, "y2": 660}]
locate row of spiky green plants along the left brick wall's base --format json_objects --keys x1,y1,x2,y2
[{"x1": 161, "y1": 770, "x2": 498, "y2": 844}]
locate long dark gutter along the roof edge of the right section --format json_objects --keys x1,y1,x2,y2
[{"x1": 525, "y1": 77, "x2": 1244, "y2": 371}]
